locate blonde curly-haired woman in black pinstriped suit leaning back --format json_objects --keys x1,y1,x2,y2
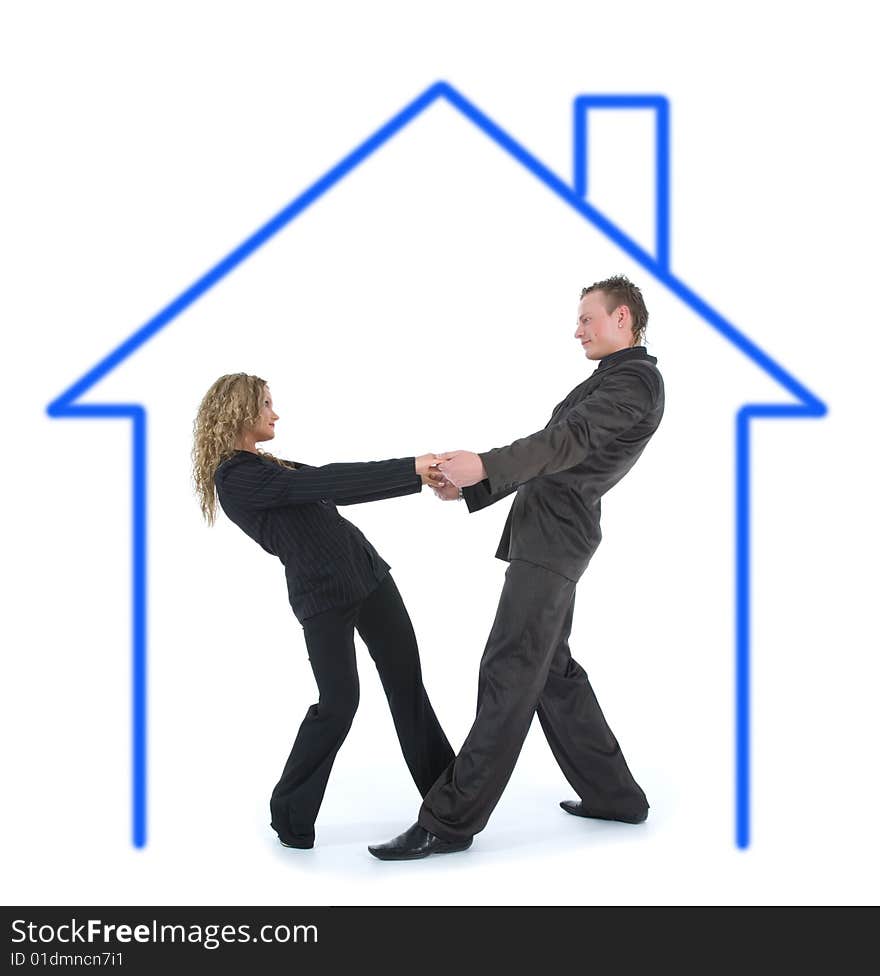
[{"x1": 193, "y1": 373, "x2": 454, "y2": 848}]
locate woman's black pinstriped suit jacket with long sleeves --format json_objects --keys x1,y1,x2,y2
[{"x1": 214, "y1": 451, "x2": 422, "y2": 622}]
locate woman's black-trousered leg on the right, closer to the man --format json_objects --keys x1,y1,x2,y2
[{"x1": 357, "y1": 574, "x2": 455, "y2": 796}]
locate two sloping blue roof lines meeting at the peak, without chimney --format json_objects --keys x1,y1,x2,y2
[{"x1": 47, "y1": 81, "x2": 826, "y2": 416}]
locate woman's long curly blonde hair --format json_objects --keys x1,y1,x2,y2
[{"x1": 192, "y1": 373, "x2": 288, "y2": 525}]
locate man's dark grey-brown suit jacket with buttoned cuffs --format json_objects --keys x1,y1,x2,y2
[{"x1": 463, "y1": 346, "x2": 664, "y2": 580}]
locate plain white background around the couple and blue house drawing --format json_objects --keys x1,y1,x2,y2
[{"x1": 0, "y1": 3, "x2": 880, "y2": 904}]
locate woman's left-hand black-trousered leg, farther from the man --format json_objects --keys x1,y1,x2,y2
[{"x1": 269, "y1": 605, "x2": 359, "y2": 847}]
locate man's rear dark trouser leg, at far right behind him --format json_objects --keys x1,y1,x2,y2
[{"x1": 538, "y1": 601, "x2": 648, "y2": 822}]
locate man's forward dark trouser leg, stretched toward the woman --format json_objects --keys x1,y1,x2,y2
[{"x1": 418, "y1": 560, "x2": 575, "y2": 842}]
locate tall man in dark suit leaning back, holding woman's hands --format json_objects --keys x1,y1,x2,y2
[{"x1": 369, "y1": 276, "x2": 664, "y2": 860}]
